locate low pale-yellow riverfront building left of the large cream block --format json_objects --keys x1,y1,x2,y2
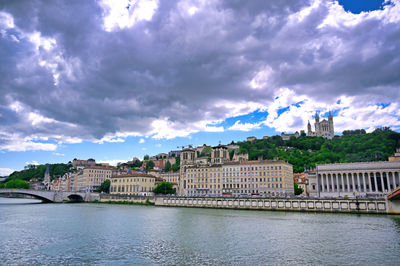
[{"x1": 110, "y1": 174, "x2": 156, "y2": 196}]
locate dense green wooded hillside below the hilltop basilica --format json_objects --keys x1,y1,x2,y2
[{"x1": 236, "y1": 127, "x2": 400, "y2": 173}]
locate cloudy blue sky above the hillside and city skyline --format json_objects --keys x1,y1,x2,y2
[{"x1": 0, "y1": 0, "x2": 400, "y2": 176}]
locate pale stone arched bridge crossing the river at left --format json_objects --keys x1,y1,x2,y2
[{"x1": 0, "y1": 188, "x2": 100, "y2": 203}]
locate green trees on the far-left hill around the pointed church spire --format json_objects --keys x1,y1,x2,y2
[{"x1": 5, "y1": 163, "x2": 72, "y2": 182}]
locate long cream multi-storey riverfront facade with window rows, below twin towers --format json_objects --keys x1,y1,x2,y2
[{"x1": 183, "y1": 160, "x2": 294, "y2": 196}]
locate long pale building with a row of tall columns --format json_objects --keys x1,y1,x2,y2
[{"x1": 316, "y1": 157, "x2": 400, "y2": 197}]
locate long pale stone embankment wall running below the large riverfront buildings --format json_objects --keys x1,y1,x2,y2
[{"x1": 155, "y1": 197, "x2": 400, "y2": 214}]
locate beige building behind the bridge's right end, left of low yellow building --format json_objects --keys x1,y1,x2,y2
[{"x1": 73, "y1": 166, "x2": 112, "y2": 191}]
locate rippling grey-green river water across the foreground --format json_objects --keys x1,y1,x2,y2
[{"x1": 0, "y1": 198, "x2": 400, "y2": 265}]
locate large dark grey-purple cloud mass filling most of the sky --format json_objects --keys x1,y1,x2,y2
[{"x1": 0, "y1": 1, "x2": 400, "y2": 149}]
